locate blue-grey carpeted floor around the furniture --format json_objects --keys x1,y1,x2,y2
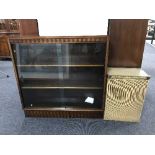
[{"x1": 0, "y1": 43, "x2": 155, "y2": 135}]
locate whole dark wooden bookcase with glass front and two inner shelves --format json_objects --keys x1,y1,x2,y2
[{"x1": 10, "y1": 36, "x2": 109, "y2": 118}]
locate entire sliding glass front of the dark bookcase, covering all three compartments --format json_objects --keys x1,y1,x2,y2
[{"x1": 12, "y1": 43, "x2": 106, "y2": 108}]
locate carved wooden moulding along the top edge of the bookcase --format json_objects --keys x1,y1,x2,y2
[{"x1": 10, "y1": 36, "x2": 108, "y2": 44}]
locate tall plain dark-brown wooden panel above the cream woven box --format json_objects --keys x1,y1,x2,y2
[{"x1": 108, "y1": 19, "x2": 148, "y2": 67}]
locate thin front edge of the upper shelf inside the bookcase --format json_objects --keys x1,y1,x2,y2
[{"x1": 17, "y1": 64, "x2": 104, "y2": 67}]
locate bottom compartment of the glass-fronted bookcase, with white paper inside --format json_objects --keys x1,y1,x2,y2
[{"x1": 23, "y1": 89, "x2": 103, "y2": 108}]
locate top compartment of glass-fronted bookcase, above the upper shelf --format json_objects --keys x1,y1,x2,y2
[{"x1": 16, "y1": 43, "x2": 106, "y2": 65}]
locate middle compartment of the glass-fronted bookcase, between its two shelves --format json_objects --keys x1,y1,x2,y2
[{"x1": 19, "y1": 66, "x2": 104, "y2": 87}]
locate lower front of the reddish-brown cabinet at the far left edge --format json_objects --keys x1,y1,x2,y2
[{"x1": 0, "y1": 36, "x2": 10, "y2": 58}]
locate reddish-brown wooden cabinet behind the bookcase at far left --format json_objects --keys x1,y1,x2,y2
[{"x1": 0, "y1": 19, "x2": 39, "y2": 59}]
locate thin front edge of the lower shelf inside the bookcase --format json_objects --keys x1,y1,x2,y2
[{"x1": 22, "y1": 86, "x2": 103, "y2": 89}]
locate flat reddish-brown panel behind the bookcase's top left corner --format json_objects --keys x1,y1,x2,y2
[{"x1": 19, "y1": 19, "x2": 39, "y2": 36}]
